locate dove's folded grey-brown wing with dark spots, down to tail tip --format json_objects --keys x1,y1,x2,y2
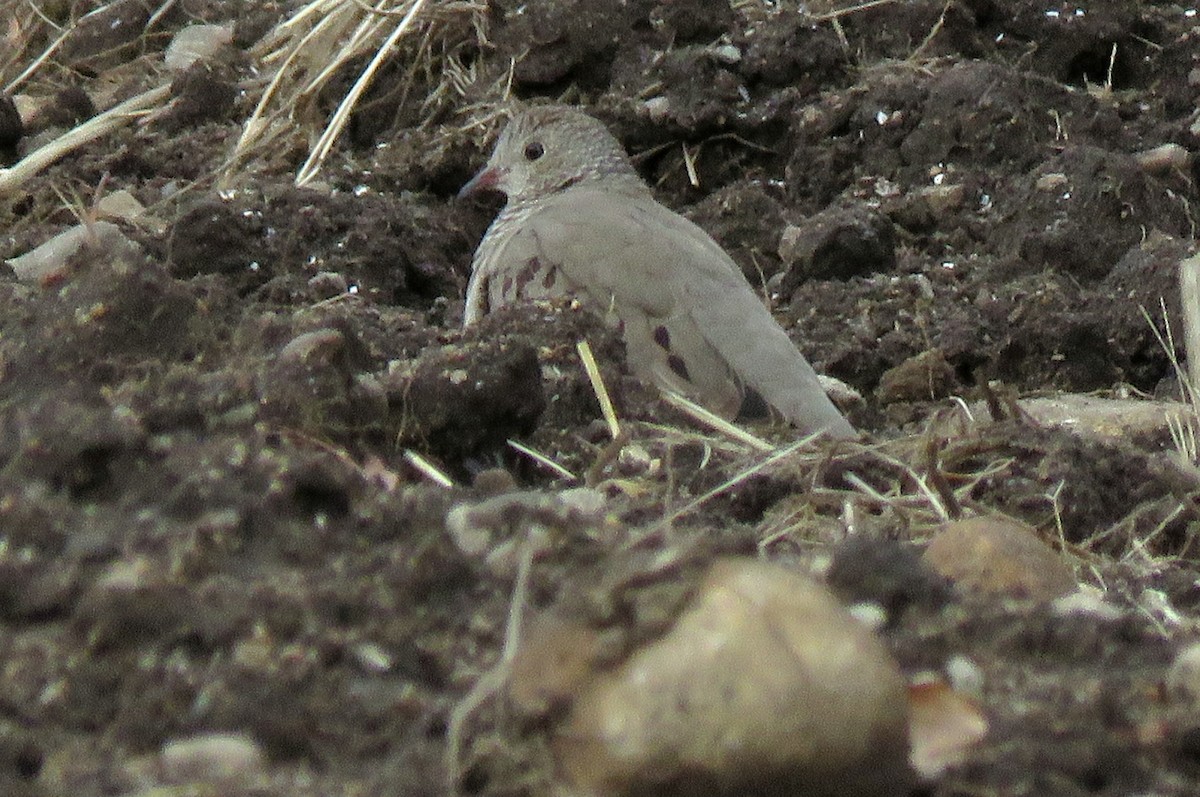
[{"x1": 496, "y1": 186, "x2": 853, "y2": 437}]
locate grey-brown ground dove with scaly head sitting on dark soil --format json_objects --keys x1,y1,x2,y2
[{"x1": 460, "y1": 106, "x2": 854, "y2": 438}]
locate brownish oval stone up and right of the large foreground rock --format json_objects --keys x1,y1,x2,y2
[{"x1": 924, "y1": 517, "x2": 1078, "y2": 601}]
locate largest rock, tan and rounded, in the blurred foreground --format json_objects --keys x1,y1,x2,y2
[{"x1": 523, "y1": 558, "x2": 911, "y2": 797}]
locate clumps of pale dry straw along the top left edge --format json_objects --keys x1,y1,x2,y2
[{"x1": 0, "y1": 0, "x2": 501, "y2": 230}]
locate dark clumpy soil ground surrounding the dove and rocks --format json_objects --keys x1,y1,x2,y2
[{"x1": 0, "y1": 0, "x2": 1200, "y2": 797}]
